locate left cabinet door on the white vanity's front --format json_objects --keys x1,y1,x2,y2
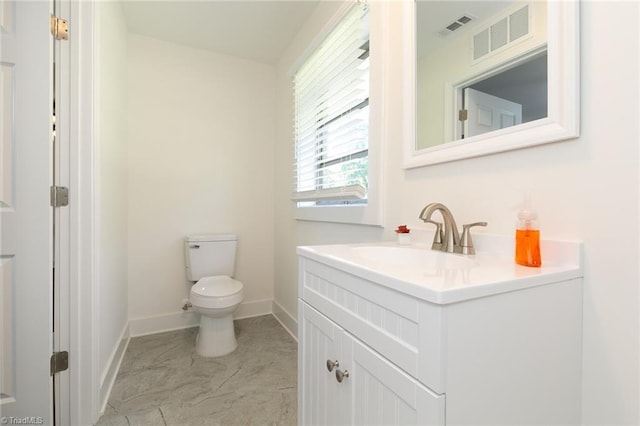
[{"x1": 298, "y1": 301, "x2": 348, "y2": 425}]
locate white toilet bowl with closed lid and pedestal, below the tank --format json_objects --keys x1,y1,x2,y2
[{"x1": 190, "y1": 275, "x2": 244, "y2": 357}]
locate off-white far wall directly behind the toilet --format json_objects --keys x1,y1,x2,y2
[{"x1": 127, "y1": 35, "x2": 275, "y2": 334}]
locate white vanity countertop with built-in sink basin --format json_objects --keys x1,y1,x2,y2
[{"x1": 297, "y1": 235, "x2": 582, "y2": 304}]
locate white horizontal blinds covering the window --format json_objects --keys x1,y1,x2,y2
[{"x1": 293, "y1": 3, "x2": 369, "y2": 203}]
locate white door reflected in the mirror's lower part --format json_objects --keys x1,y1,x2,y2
[{"x1": 463, "y1": 87, "x2": 522, "y2": 138}]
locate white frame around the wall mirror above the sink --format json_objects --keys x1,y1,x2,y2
[{"x1": 403, "y1": 0, "x2": 580, "y2": 169}]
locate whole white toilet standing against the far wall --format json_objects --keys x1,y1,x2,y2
[{"x1": 184, "y1": 234, "x2": 244, "y2": 357}]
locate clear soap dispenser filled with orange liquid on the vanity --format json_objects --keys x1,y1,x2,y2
[{"x1": 516, "y1": 194, "x2": 542, "y2": 267}]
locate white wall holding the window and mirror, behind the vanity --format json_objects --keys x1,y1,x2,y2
[{"x1": 275, "y1": 1, "x2": 640, "y2": 424}]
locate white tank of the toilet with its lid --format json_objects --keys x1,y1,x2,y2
[{"x1": 184, "y1": 234, "x2": 237, "y2": 281}]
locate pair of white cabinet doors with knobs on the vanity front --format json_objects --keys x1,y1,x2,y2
[{"x1": 298, "y1": 301, "x2": 444, "y2": 425}]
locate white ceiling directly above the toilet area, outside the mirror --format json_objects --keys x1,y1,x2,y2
[{"x1": 122, "y1": 0, "x2": 321, "y2": 65}]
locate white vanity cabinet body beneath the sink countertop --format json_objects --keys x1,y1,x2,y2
[{"x1": 298, "y1": 246, "x2": 582, "y2": 425}]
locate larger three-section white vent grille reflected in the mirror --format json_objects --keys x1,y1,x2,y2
[{"x1": 472, "y1": 5, "x2": 530, "y2": 60}]
